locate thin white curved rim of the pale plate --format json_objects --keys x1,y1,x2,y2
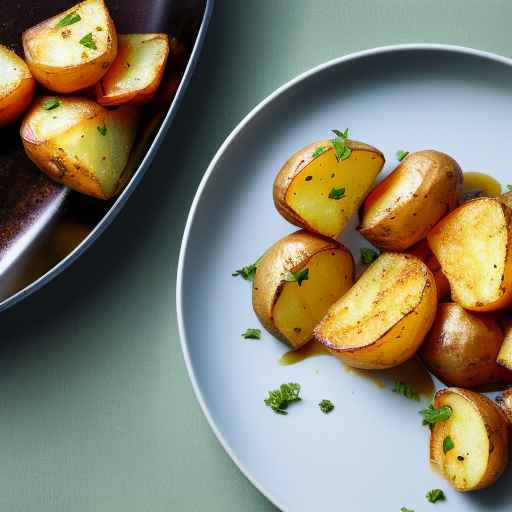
[{"x1": 176, "y1": 43, "x2": 512, "y2": 511}]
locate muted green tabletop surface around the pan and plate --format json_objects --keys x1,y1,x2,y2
[{"x1": 6, "y1": 0, "x2": 512, "y2": 512}]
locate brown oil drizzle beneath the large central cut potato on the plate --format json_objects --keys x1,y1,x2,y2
[{"x1": 279, "y1": 340, "x2": 435, "y2": 399}]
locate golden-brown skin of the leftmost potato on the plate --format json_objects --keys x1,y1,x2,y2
[{"x1": 252, "y1": 230, "x2": 354, "y2": 348}]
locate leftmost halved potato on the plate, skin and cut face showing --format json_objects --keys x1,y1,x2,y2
[{"x1": 252, "y1": 231, "x2": 354, "y2": 348}]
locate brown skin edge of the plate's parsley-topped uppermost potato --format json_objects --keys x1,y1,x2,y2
[{"x1": 273, "y1": 139, "x2": 384, "y2": 235}]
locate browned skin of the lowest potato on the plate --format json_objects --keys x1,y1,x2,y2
[{"x1": 430, "y1": 387, "x2": 509, "y2": 492}]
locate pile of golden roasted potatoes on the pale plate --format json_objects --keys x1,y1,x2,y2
[{"x1": 253, "y1": 131, "x2": 512, "y2": 491}]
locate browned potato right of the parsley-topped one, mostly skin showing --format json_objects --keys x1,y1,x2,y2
[{"x1": 359, "y1": 149, "x2": 462, "y2": 251}]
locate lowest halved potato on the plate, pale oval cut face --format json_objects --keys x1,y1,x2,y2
[{"x1": 430, "y1": 388, "x2": 509, "y2": 492}]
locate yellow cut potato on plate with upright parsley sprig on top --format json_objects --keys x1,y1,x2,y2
[{"x1": 274, "y1": 140, "x2": 384, "y2": 238}]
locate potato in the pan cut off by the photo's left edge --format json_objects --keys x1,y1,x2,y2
[{"x1": 0, "y1": 44, "x2": 35, "y2": 126}]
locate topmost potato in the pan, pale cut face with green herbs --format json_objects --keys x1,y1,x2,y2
[{"x1": 22, "y1": 0, "x2": 117, "y2": 93}]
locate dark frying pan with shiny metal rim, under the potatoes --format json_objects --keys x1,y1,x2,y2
[{"x1": 0, "y1": 0, "x2": 213, "y2": 311}]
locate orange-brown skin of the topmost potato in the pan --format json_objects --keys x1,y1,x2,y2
[{"x1": 22, "y1": 3, "x2": 117, "y2": 93}]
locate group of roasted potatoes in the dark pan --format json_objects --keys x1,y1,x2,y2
[{"x1": 0, "y1": 0, "x2": 169, "y2": 199}]
